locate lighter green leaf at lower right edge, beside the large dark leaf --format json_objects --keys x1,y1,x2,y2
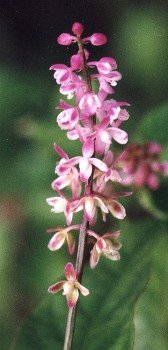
[{"x1": 134, "y1": 231, "x2": 168, "y2": 350}]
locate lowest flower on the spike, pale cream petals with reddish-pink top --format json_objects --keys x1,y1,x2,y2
[{"x1": 48, "y1": 262, "x2": 89, "y2": 308}]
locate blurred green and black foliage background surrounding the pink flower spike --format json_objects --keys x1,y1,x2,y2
[{"x1": 0, "y1": 0, "x2": 168, "y2": 350}]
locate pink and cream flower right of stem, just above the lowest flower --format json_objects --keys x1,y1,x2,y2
[{"x1": 88, "y1": 230, "x2": 122, "y2": 269}]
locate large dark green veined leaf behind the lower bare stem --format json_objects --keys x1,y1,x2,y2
[{"x1": 13, "y1": 220, "x2": 164, "y2": 350}]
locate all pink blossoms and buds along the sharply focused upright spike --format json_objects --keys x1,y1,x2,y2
[{"x1": 47, "y1": 23, "x2": 167, "y2": 307}]
